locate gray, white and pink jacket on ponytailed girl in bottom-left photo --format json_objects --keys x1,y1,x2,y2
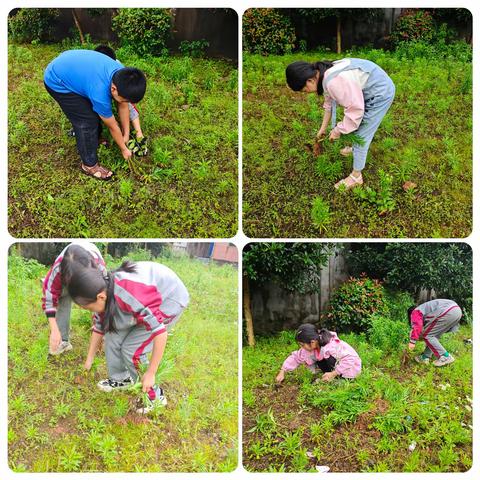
[{"x1": 93, "y1": 262, "x2": 190, "y2": 335}]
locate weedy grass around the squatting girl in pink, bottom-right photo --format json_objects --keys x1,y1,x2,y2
[{"x1": 243, "y1": 325, "x2": 472, "y2": 472}]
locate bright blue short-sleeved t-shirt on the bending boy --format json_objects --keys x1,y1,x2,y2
[{"x1": 43, "y1": 50, "x2": 123, "y2": 118}]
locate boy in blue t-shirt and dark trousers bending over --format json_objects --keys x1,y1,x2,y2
[{"x1": 44, "y1": 50, "x2": 146, "y2": 180}]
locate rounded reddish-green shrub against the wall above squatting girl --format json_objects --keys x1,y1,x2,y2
[{"x1": 326, "y1": 277, "x2": 387, "y2": 332}]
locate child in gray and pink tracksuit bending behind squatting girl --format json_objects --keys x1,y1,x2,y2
[{"x1": 407, "y1": 298, "x2": 462, "y2": 367}]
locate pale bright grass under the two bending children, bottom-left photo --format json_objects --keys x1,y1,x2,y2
[{"x1": 8, "y1": 255, "x2": 238, "y2": 472}]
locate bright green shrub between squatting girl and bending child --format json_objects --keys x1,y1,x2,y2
[{"x1": 368, "y1": 315, "x2": 409, "y2": 352}]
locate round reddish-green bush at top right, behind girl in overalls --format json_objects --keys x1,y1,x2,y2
[{"x1": 390, "y1": 9, "x2": 435, "y2": 47}]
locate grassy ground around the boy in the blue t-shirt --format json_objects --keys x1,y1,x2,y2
[{"x1": 8, "y1": 45, "x2": 238, "y2": 238}]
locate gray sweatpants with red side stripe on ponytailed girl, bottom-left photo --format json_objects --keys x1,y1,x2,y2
[{"x1": 104, "y1": 312, "x2": 181, "y2": 382}]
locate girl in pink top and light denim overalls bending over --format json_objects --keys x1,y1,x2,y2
[{"x1": 286, "y1": 58, "x2": 395, "y2": 189}]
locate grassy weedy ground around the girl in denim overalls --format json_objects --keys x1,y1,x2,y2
[{"x1": 243, "y1": 50, "x2": 472, "y2": 238}]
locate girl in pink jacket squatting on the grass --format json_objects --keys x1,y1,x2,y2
[{"x1": 276, "y1": 323, "x2": 362, "y2": 382}]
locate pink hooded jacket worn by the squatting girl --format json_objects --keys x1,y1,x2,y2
[{"x1": 282, "y1": 332, "x2": 362, "y2": 378}]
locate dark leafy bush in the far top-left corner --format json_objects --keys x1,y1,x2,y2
[{"x1": 8, "y1": 8, "x2": 59, "y2": 43}]
